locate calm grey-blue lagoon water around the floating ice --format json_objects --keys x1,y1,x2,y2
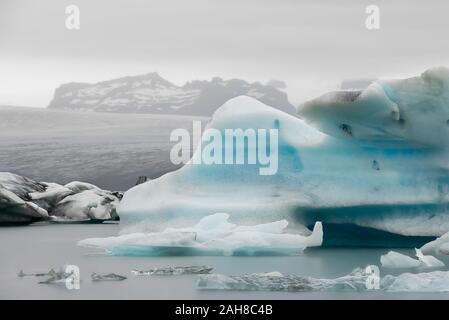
[{"x1": 0, "y1": 224, "x2": 449, "y2": 300}]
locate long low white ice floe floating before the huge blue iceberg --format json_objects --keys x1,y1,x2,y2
[{"x1": 78, "y1": 213, "x2": 323, "y2": 256}]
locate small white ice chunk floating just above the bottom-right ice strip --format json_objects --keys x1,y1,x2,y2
[{"x1": 380, "y1": 249, "x2": 444, "y2": 268}]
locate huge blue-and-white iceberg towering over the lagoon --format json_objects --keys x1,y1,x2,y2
[{"x1": 114, "y1": 68, "x2": 449, "y2": 240}]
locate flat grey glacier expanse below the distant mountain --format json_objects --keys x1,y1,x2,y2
[{"x1": 0, "y1": 107, "x2": 206, "y2": 191}]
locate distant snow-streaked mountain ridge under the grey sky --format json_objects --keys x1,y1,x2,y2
[{"x1": 49, "y1": 73, "x2": 296, "y2": 116}]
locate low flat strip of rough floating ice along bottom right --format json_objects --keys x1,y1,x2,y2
[{"x1": 197, "y1": 268, "x2": 449, "y2": 292}]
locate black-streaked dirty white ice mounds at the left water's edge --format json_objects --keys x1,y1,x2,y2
[{"x1": 0, "y1": 172, "x2": 121, "y2": 224}]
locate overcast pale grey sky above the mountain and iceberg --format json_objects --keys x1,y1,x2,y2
[{"x1": 0, "y1": 0, "x2": 449, "y2": 107}]
